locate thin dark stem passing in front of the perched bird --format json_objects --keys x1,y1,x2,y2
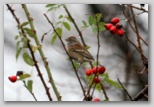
[{"x1": 44, "y1": 14, "x2": 86, "y2": 100}]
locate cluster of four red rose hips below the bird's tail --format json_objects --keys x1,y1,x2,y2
[{"x1": 86, "y1": 66, "x2": 106, "y2": 84}]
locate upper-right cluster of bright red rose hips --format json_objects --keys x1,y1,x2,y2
[{"x1": 105, "y1": 17, "x2": 124, "y2": 37}]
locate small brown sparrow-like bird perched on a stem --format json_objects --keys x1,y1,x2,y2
[{"x1": 65, "y1": 36, "x2": 94, "y2": 63}]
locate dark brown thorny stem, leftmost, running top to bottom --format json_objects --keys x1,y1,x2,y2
[{"x1": 6, "y1": 4, "x2": 52, "y2": 101}]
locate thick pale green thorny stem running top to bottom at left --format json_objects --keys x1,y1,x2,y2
[{"x1": 22, "y1": 4, "x2": 61, "y2": 101}]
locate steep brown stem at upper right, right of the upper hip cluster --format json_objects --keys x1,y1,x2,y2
[{"x1": 130, "y1": 5, "x2": 144, "y2": 62}]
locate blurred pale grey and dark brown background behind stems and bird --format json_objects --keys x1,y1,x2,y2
[{"x1": 4, "y1": 4, "x2": 149, "y2": 101}]
